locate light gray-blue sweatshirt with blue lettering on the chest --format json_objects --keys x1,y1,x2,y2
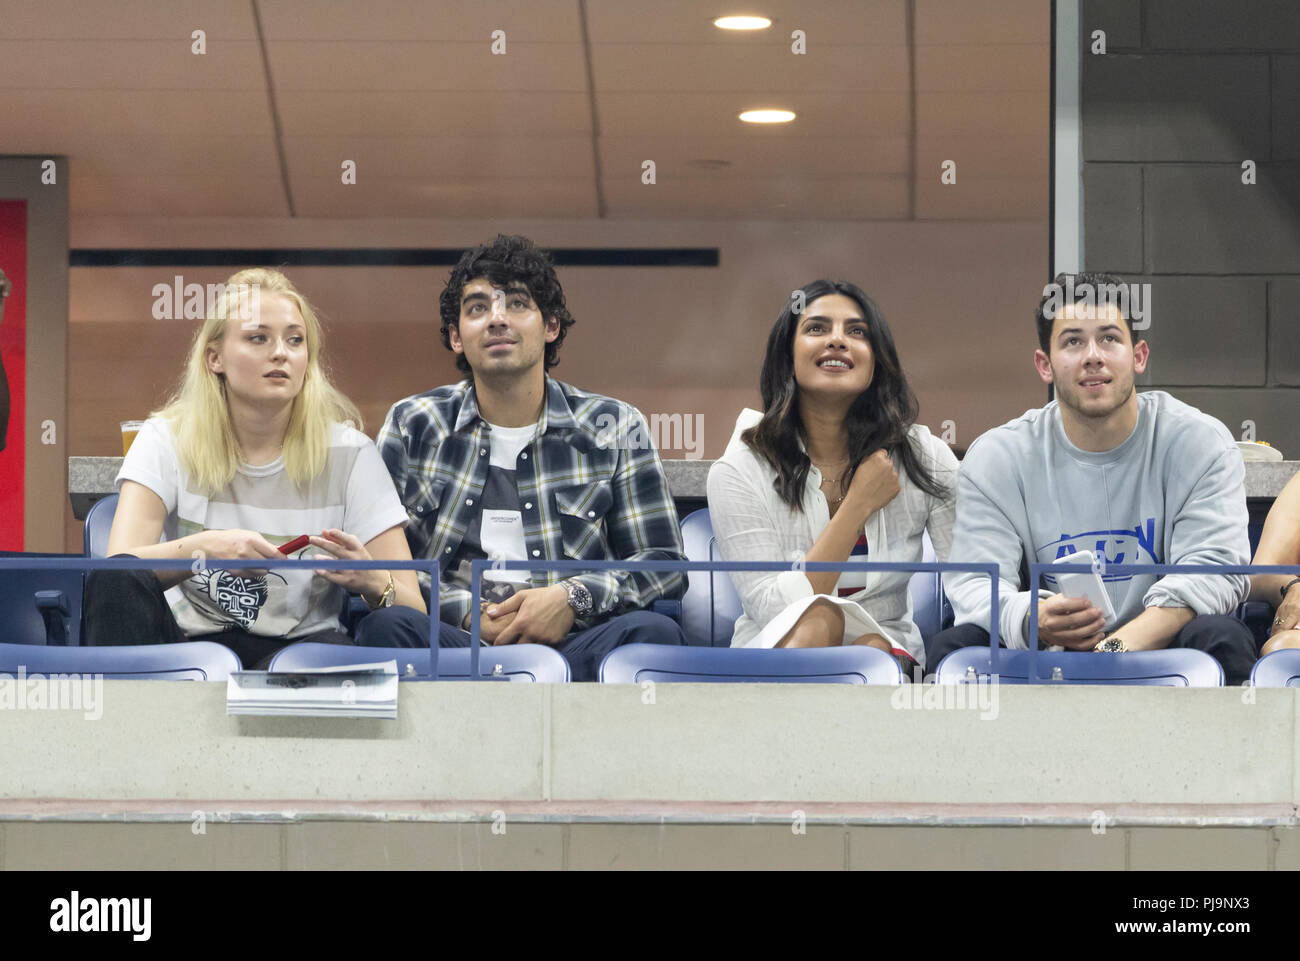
[{"x1": 944, "y1": 390, "x2": 1251, "y2": 648}]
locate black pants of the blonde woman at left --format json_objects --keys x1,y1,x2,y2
[{"x1": 82, "y1": 571, "x2": 429, "y2": 671}]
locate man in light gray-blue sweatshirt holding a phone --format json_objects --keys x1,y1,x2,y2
[{"x1": 926, "y1": 274, "x2": 1256, "y2": 684}]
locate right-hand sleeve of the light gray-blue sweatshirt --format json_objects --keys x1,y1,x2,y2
[{"x1": 1143, "y1": 446, "x2": 1251, "y2": 614}]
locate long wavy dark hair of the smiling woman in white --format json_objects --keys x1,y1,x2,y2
[{"x1": 741, "y1": 280, "x2": 946, "y2": 510}]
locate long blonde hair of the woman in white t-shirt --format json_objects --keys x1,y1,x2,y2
[{"x1": 150, "y1": 268, "x2": 361, "y2": 494}]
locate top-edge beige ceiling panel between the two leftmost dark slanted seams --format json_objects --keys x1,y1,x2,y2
[{"x1": 257, "y1": 0, "x2": 579, "y2": 41}]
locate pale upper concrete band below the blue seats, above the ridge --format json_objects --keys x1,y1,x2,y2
[{"x1": 0, "y1": 680, "x2": 1300, "y2": 817}]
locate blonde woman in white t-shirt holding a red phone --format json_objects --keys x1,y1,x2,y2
[{"x1": 85, "y1": 269, "x2": 429, "y2": 667}]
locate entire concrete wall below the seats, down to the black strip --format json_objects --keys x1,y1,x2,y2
[{"x1": 0, "y1": 681, "x2": 1300, "y2": 869}]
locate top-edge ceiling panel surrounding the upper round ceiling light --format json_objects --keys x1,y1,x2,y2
[{"x1": 586, "y1": 0, "x2": 907, "y2": 44}]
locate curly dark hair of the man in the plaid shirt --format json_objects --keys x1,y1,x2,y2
[{"x1": 438, "y1": 234, "x2": 573, "y2": 373}]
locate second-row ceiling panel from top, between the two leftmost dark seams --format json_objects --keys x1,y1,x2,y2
[{"x1": 267, "y1": 40, "x2": 586, "y2": 91}]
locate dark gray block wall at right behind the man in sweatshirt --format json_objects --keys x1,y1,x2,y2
[{"x1": 1082, "y1": 0, "x2": 1300, "y2": 459}]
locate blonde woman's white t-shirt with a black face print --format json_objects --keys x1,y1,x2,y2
[{"x1": 116, "y1": 417, "x2": 407, "y2": 638}]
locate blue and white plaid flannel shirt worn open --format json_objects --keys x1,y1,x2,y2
[{"x1": 378, "y1": 377, "x2": 686, "y2": 629}]
